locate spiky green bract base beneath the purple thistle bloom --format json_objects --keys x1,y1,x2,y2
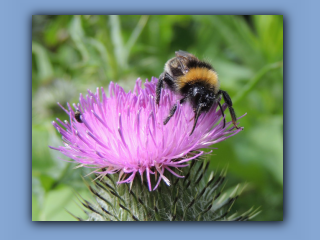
[{"x1": 76, "y1": 160, "x2": 259, "y2": 221}]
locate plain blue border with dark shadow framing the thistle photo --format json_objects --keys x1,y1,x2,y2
[{"x1": 0, "y1": 0, "x2": 320, "y2": 240}]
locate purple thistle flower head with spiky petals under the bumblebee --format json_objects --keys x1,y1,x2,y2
[{"x1": 50, "y1": 78, "x2": 243, "y2": 191}]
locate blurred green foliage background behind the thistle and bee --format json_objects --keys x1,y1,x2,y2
[{"x1": 32, "y1": 15, "x2": 283, "y2": 221}]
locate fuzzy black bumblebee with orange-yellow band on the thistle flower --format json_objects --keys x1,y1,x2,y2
[{"x1": 156, "y1": 50, "x2": 239, "y2": 136}]
